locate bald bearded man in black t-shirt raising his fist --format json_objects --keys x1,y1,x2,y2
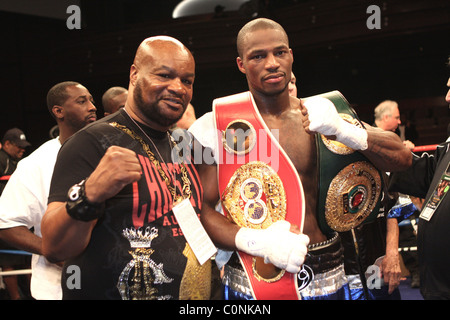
[{"x1": 42, "y1": 36, "x2": 209, "y2": 300}]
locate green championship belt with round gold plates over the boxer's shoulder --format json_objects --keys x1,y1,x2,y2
[{"x1": 304, "y1": 91, "x2": 382, "y2": 234}]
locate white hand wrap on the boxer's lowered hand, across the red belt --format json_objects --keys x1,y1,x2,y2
[{"x1": 235, "y1": 221, "x2": 309, "y2": 273}]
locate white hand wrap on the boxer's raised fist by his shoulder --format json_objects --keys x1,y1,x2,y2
[{"x1": 303, "y1": 97, "x2": 367, "y2": 150}]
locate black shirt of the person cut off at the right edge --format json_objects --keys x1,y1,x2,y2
[{"x1": 390, "y1": 143, "x2": 450, "y2": 299}]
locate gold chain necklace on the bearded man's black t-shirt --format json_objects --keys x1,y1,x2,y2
[{"x1": 110, "y1": 109, "x2": 191, "y2": 204}]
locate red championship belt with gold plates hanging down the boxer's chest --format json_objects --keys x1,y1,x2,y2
[{"x1": 213, "y1": 92, "x2": 305, "y2": 300}]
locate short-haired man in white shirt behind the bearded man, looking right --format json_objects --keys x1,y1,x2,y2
[{"x1": 0, "y1": 81, "x2": 97, "y2": 300}]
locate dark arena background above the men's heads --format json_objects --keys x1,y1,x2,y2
[{"x1": 0, "y1": 0, "x2": 450, "y2": 151}]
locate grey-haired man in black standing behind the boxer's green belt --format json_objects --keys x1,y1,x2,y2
[{"x1": 341, "y1": 100, "x2": 408, "y2": 300}]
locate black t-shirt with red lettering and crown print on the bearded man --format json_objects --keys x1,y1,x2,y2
[{"x1": 49, "y1": 110, "x2": 202, "y2": 299}]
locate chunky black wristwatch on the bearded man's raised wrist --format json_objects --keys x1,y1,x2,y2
[{"x1": 66, "y1": 179, "x2": 105, "y2": 221}]
